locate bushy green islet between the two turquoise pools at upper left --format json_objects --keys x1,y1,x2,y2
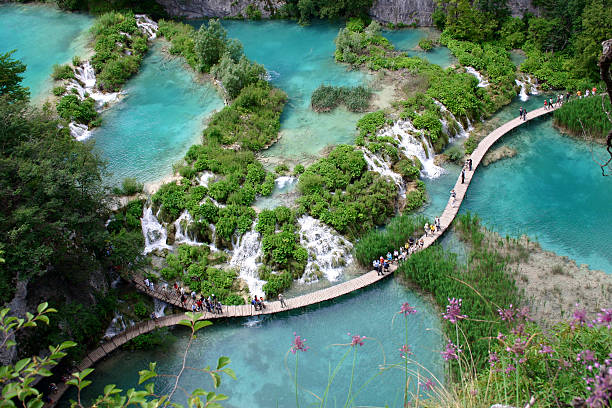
[{"x1": 91, "y1": 11, "x2": 148, "y2": 92}]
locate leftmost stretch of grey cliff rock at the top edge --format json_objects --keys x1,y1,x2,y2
[{"x1": 157, "y1": 0, "x2": 285, "y2": 18}]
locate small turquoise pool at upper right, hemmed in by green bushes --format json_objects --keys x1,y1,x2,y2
[{"x1": 383, "y1": 28, "x2": 457, "y2": 68}]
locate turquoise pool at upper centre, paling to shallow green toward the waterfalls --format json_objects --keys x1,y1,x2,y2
[{"x1": 193, "y1": 21, "x2": 368, "y2": 162}]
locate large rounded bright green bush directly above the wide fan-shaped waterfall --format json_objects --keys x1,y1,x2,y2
[{"x1": 298, "y1": 145, "x2": 397, "y2": 238}]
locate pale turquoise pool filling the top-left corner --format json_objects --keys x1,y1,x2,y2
[{"x1": 0, "y1": 4, "x2": 93, "y2": 100}]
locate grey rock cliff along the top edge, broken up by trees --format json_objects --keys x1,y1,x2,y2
[{"x1": 155, "y1": 0, "x2": 538, "y2": 26}]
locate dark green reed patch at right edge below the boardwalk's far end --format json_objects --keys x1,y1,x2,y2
[{"x1": 553, "y1": 97, "x2": 612, "y2": 140}]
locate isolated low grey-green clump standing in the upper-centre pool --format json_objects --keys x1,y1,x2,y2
[{"x1": 310, "y1": 85, "x2": 372, "y2": 112}]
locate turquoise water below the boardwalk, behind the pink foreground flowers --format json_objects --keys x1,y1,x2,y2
[{"x1": 67, "y1": 279, "x2": 443, "y2": 408}]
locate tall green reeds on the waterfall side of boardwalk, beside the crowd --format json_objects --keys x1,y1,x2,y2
[{"x1": 354, "y1": 215, "x2": 428, "y2": 267}]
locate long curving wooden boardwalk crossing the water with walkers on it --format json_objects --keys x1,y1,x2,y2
[{"x1": 46, "y1": 104, "x2": 554, "y2": 405}]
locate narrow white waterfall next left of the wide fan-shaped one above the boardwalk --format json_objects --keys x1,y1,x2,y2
[{"x1": 230, "y1": 230, "x2": 266, "y2": 296}]
